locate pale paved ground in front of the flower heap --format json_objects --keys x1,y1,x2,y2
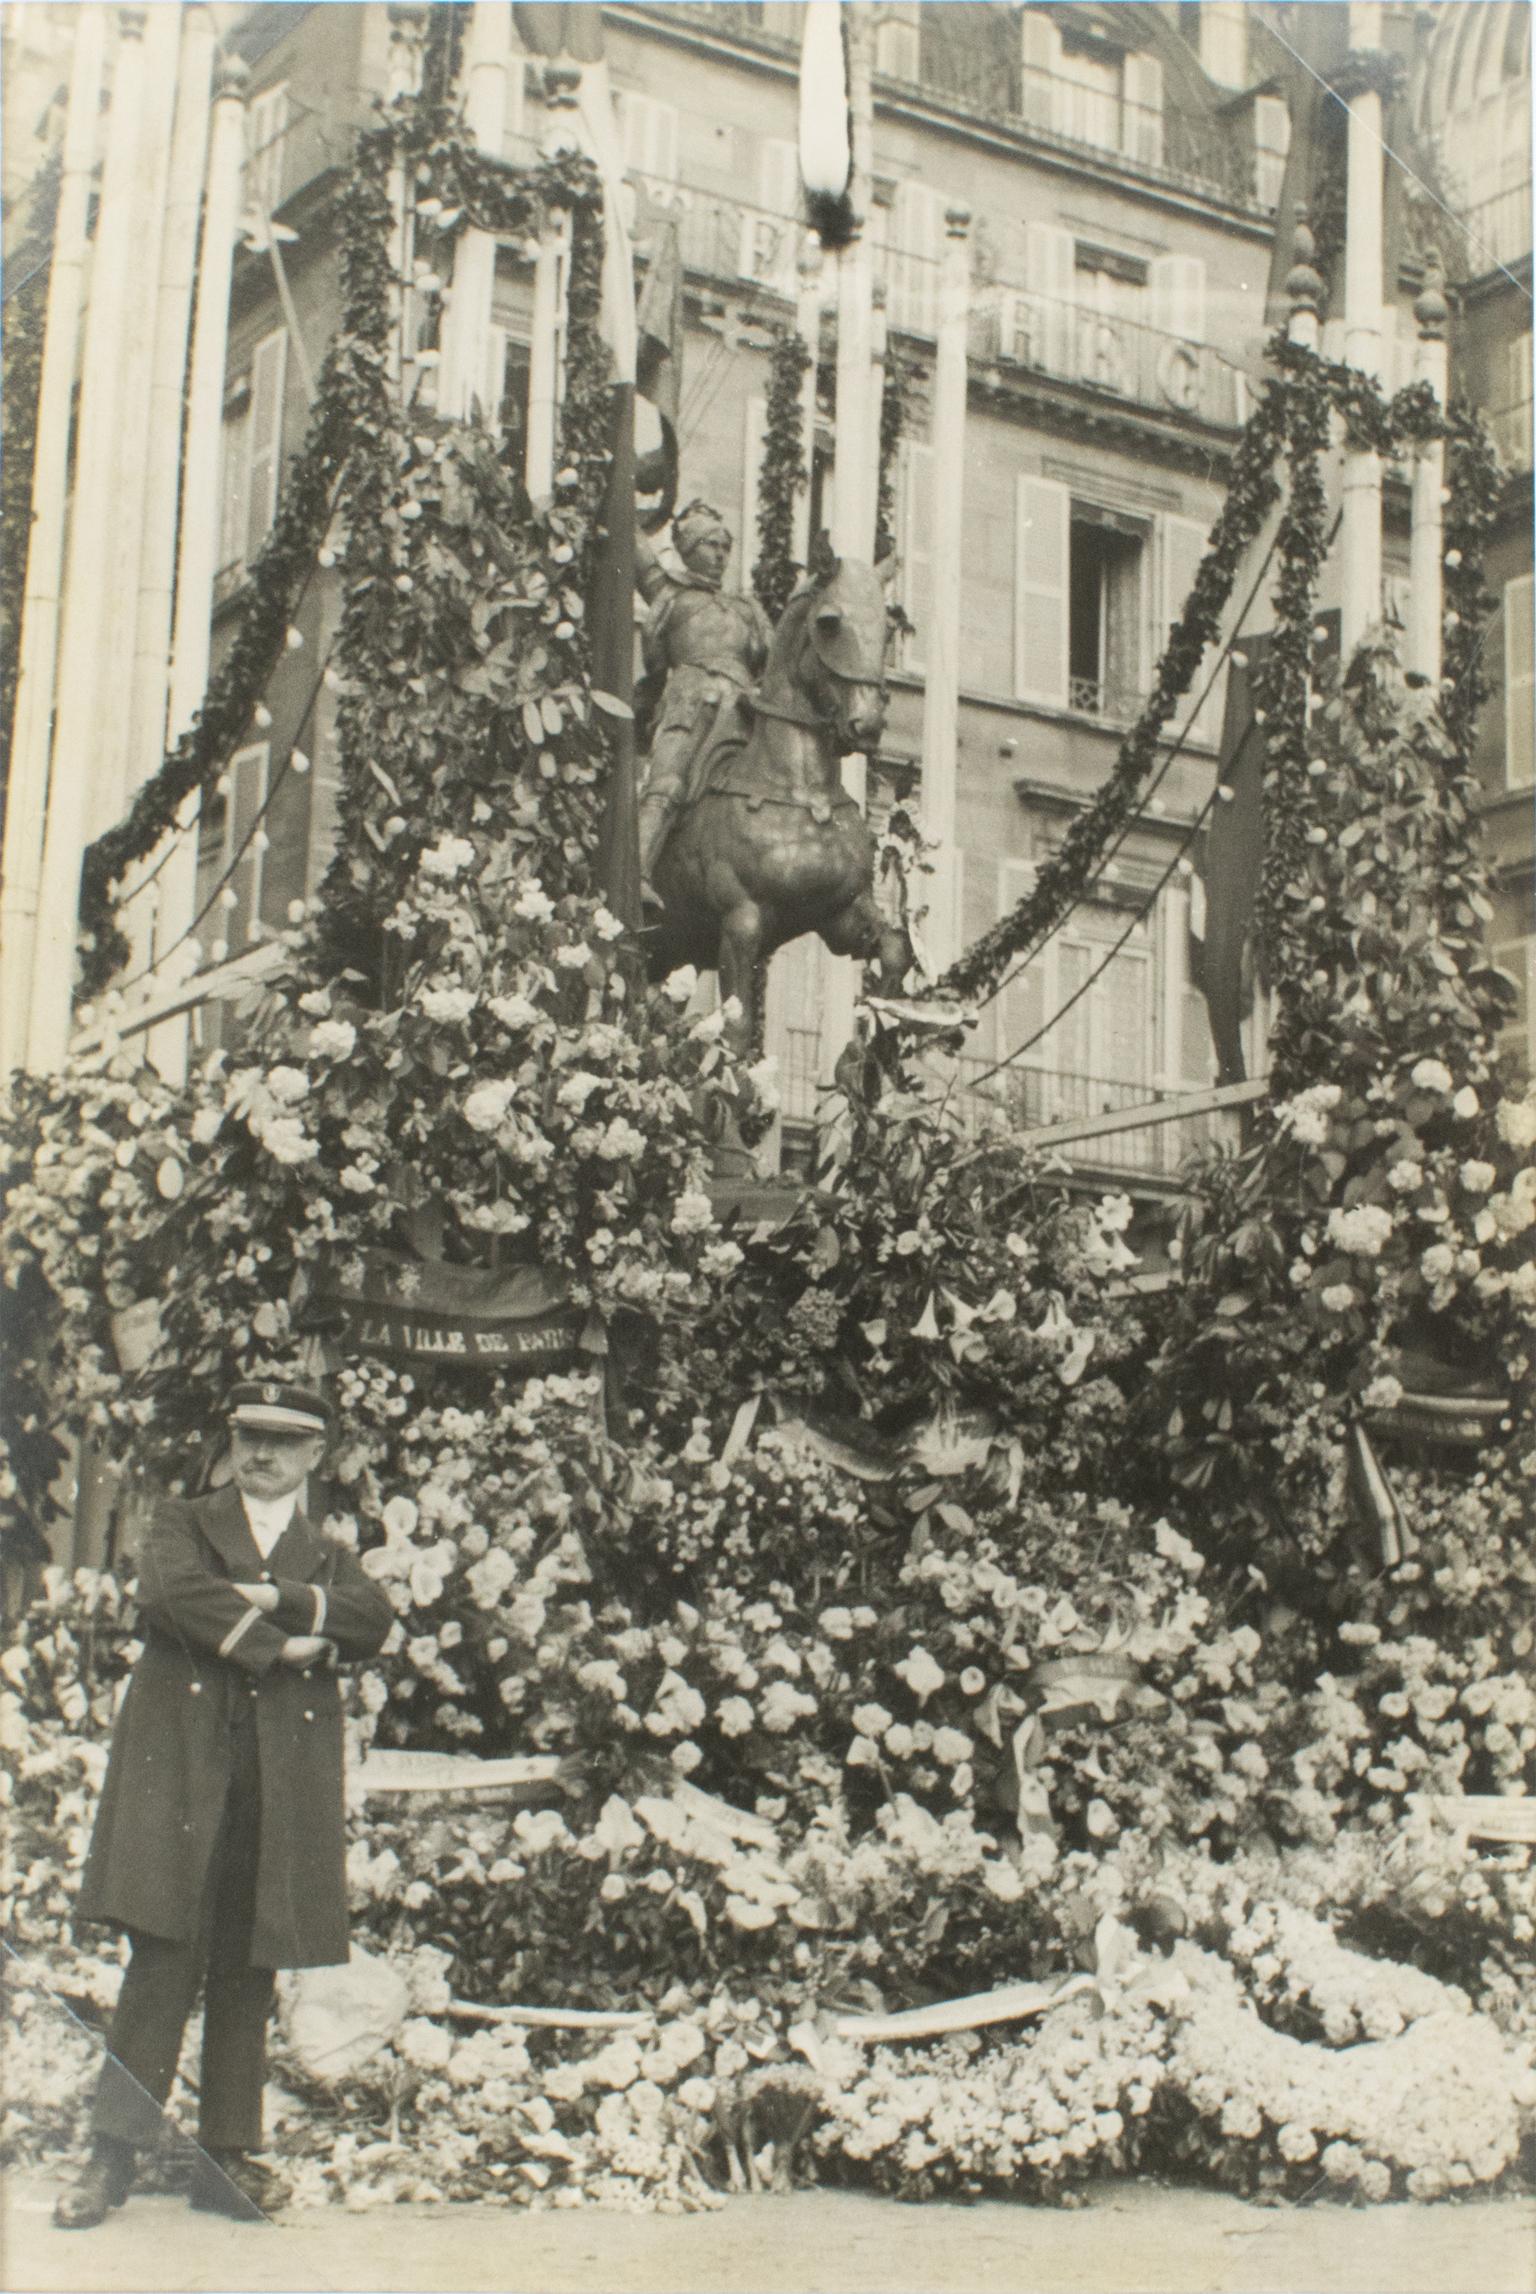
[{"x1": 2, "y1": 2175, "x2": 1536, "y2": 2294}]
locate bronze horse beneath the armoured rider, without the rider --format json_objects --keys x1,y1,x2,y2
[{"x1": 646, "y1": 541, "x2": 910, "y2": 1046}]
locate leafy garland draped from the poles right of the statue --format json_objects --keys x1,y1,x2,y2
[{"x1": 928, "y1": 335, "x2": 1499, "y2": 998}]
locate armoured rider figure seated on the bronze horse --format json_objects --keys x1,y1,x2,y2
[{"x1": 635, "y1": 502, "x2": 773, "y2": 902}]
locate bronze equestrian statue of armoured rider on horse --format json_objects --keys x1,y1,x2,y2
[{"x1": 640, "y1": 502, "x2": 910, "y2": 1046}]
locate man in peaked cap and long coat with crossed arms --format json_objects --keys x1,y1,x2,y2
[{"x1": 55, "y1": 1379, "x2": 394, "y2": 2230}]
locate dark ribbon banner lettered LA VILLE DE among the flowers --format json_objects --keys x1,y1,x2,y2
[{"x1": 316, "y1": 1250, "x2": 608, "y2": 1376}]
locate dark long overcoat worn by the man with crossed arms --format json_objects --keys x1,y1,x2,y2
[{"x1": 76, "y1": 1487, "x2": 394, "y2": 1968}]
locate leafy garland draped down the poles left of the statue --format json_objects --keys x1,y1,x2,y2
[{"x1": 80, "y1": 103, "x2": 605, "y2": 996}]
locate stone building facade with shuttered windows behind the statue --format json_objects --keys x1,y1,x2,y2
[{"x1": 6, "y1": 0, "x2": 1534, "y2": 1156}]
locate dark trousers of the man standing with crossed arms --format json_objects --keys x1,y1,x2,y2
[{"x1": 92, "y1": 1711, "x2": 273, "y2": 2149}]
